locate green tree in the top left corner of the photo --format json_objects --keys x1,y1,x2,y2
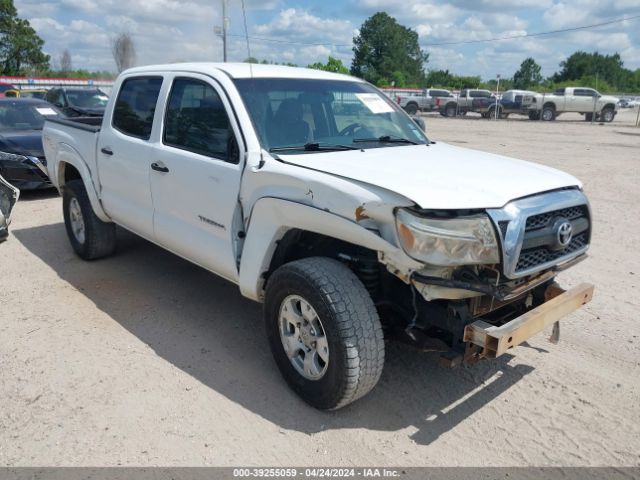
[{"x1": 0, "y1": 0, "x2": 49, "y2": 75}]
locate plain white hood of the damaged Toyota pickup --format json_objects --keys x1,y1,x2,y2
[{"x1": 280, "y1": 142, "x2": 581, "y2": 209}]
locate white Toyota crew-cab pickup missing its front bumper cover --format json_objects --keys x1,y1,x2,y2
[{"x1": 43, "y1": 63, "x2": 593, "y2": 409}]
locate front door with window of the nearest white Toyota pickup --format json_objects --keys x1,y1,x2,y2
[{"x1": 147, "y1": 73, "x2": 244, "y2": 281}]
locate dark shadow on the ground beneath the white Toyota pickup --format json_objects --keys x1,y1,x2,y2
[{"x1": 12, "y1": 223, "x2": 533, "y2": 445}]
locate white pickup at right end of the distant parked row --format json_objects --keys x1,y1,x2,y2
[{"x1": 523, "y1": 87, "x2": 619, "y2": 123}]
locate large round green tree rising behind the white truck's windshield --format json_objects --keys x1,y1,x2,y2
[{"x1": 351, "y1": 12, "x2": 429, "y2": 86}]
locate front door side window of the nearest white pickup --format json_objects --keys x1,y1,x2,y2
[{"x1": 163, "y1": 78, "x2": 239, "y2": 163}]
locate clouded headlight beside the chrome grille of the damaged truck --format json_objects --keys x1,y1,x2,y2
[{"x1": 396, "y1": 209, "x2": 500, "y2": 266}]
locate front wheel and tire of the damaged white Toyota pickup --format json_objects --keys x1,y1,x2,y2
[{"x1": 264, "y1": 257, "x2": 384, "y2": 410}]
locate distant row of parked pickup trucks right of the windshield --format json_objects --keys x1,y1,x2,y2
[{"x1": 395, "y1": 87, "x2": 623, "y2": 122}]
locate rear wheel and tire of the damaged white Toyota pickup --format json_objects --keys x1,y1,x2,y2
[{"x1": 62, "y1": 180, "x2": 116, "y2": 260}]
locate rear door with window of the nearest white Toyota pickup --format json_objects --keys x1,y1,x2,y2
[{"x1": 96, "y1": 75, "x2": 163, "y2": 239}]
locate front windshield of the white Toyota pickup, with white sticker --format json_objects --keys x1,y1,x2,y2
[{"x1": 235, "y1": 78, "x2": 428, "y2": 153}]
